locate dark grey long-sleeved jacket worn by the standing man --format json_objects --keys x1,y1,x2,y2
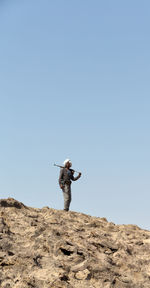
[{"x1": 59, "y1": 168, "x2": 80, "y2": 185}]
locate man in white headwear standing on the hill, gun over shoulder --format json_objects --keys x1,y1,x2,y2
[{"x1": 59, "y1": 159, "x2": 81, "y2": 211}]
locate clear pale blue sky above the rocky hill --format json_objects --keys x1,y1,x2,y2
[{"x1": 0, "y1": 0, "x2": 150, "y2": 230}]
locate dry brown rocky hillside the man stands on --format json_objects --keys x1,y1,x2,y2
[{"x1": 0, "y1": 198, "x2": 150, "y2": 288}]
